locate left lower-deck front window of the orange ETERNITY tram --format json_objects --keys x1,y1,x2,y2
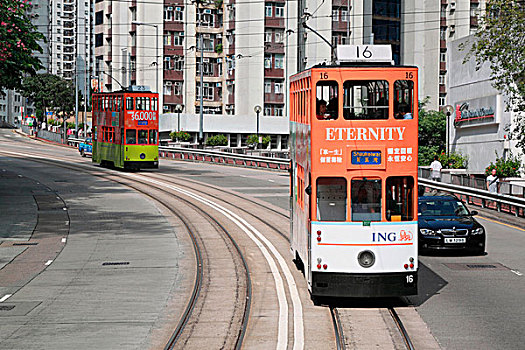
[{"x1": 317, "y1": 177, "x2": 347, "y2": 221}]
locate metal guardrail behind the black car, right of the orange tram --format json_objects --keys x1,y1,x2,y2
[{"x1": 418, "y1": 178, "x2": 525, "y2": 217}]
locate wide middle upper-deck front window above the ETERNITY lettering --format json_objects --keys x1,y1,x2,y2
[{"x1": 343, "y1": 80, "x2": 388, "y2": 120}]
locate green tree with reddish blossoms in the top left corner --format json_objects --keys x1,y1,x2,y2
[{"x1": 0, "y1": 0, "x2": 44, "y2": 90}]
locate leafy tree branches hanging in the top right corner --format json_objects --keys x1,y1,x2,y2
[{"x1": 465, "y1": 0, "x2": 525, "y2": 153}]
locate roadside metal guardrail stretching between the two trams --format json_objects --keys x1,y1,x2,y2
[{"x1": 159, "y1": 146, "x2": 290, "y2": 170}]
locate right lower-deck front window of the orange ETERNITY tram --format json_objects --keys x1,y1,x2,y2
[{"x1": 386, "y1": 176, "x2": 414, "y2": 221}]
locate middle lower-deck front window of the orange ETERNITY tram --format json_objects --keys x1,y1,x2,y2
[{"x1": 351, "y1": 178, "x2": 381, "y2": 221}]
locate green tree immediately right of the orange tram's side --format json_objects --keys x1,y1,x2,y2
[{"x1": 418, "y1": 99, "x2": 447, "y2": 165}]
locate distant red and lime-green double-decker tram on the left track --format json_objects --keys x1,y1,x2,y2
[{"x1": 93, "y1": 90, "x2": 159, "y2": 170}]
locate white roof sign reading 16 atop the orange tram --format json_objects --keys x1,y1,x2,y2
[{"x1": 337, "y1": 45, "x2": 392, "y2": 62}]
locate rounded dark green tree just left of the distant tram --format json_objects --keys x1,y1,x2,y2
[{"x1": 21, "y1": 73, "x2": 75, "y2": 119}]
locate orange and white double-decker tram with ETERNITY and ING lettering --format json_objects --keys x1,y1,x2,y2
[{"x1": 290, "y1": 45, "x2": 418, "y2": 297}]
